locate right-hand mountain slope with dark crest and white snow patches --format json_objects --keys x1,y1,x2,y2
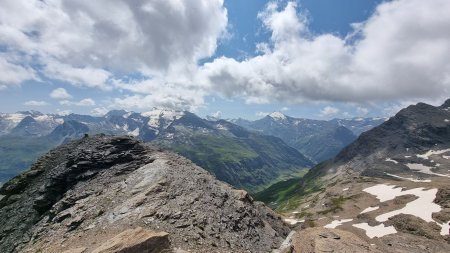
[{"x1": 256, "y1": 100, "x2": 450, "y2": 252}]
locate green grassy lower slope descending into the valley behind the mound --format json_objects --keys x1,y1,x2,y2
[{"x1": 164, "y1": 135, "x2": 305, "y2": 192}]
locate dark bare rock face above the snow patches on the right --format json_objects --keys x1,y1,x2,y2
[{"x1": 334, "y1": 101, "x2": 450, "y2": 168}]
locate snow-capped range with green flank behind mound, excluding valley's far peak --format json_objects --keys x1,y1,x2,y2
[{"x1": 0, "y1": 109, "x2": 320, "y2": 192}]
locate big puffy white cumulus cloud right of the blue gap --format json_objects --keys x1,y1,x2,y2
[{"x1": 201, "y1": 0, "x2": 450, "y2": 103}]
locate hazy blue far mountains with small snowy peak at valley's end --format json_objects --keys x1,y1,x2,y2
[{"x1": 232, "y1": 112, "x2": 386, "y2": 163}]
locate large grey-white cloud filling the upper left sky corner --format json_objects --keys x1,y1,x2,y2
[{"x1": 0, "y1": 0, "x2": 227, "y2": 93}]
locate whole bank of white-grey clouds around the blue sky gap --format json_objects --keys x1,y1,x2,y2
[{"x1": 0, "y1": 0, "x2": 450, "y2": 110}]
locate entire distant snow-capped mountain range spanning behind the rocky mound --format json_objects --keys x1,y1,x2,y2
[{"x1": 0, "y1": 108, "x2": 380, "y2": 192}]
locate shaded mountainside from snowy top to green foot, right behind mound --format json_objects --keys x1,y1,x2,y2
[{"x1": 156, "y1": 113, "x2": 312, "y2": 191}]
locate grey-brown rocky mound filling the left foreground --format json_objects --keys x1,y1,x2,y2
[{"x1": 0, "y1": 136, "x2": 289, "y2": 253}]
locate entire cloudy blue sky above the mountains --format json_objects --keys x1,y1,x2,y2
[{"x1": 0, "y1": 0, "x2": 450, "y2": 119}]
